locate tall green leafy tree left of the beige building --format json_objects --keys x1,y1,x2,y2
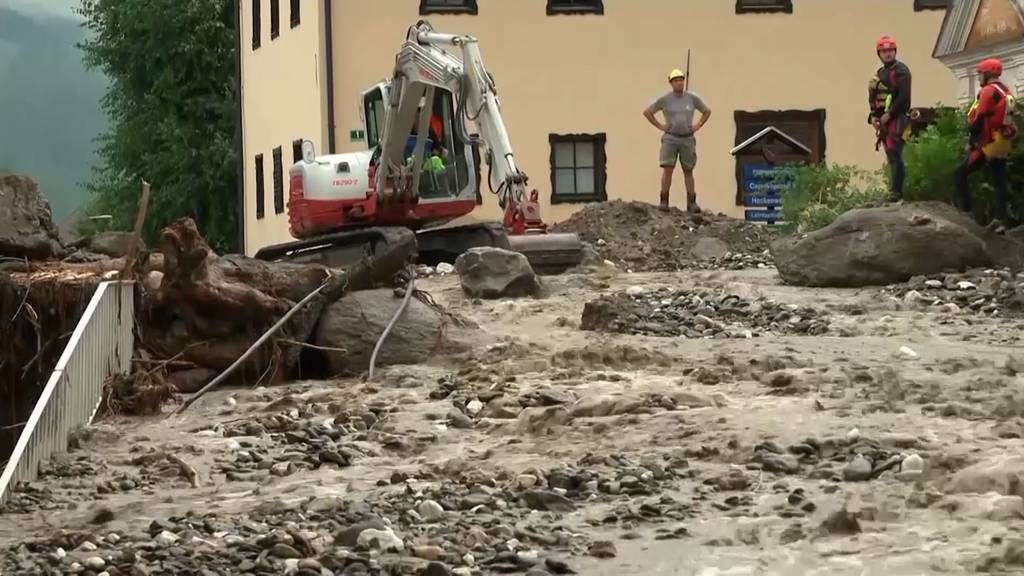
[{"x1": 78, "y1": 0, "x2": 239, "y2": 252}]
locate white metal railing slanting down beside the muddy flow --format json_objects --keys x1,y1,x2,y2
[{"x1": 0, "y1": 282, "x2": 135, "y2": 504}]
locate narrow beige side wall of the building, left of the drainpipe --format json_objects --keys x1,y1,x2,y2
[{"x1": 240, "y1": 0, "x2": 327, "y2": 254}]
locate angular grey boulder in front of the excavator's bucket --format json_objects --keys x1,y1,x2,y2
[{"x1": 455, "y1": 246, "x2": 541, "y2": 298}]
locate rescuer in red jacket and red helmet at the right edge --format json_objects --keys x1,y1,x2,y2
[{"x1": 953, "y1": 58, "x2": 1017, "y2": 229}]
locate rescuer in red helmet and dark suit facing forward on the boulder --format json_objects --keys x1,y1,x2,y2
[{"x1": 871, "y1": 36, "x2": 911, "y2": 202}]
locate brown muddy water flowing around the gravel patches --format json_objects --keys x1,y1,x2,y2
[{"x1": 0, "y1": 270, "x2": 1024, "y2": 576}]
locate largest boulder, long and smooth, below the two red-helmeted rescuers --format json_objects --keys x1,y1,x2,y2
[{"x1": 771, "y1": 202, "x2": 1024, "y2": 287}]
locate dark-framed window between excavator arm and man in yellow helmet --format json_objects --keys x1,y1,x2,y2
[{"x1": 548, "y1": 133, "x2": 608, "y2": 204}]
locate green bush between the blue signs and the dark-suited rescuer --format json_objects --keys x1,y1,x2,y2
[{"x1": 780, "y1": 162, "x2": 888, "y2": 233}]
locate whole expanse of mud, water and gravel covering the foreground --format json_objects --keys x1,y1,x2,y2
[{"x1": 0, "y1": 218, "x2": 1024, "y2": 576}]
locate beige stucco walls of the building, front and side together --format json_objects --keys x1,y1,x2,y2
[{"x1": 235, "y1": 0, "x2": 957, "y2": 252}]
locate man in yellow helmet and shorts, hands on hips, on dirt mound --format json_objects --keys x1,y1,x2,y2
[{"x1": 643, "y1": 70, "x2": 711, "y2": 213}]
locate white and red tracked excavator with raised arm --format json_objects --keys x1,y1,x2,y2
[{"x1": 255, "y1": 20, "x2": 583, "y2": 282}]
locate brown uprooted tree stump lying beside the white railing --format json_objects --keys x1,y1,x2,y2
[{"x1": 139, "y1": 218, "x2": 356, "y2": 381}]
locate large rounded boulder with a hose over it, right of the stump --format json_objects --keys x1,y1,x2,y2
[{"x1": 312, "y1": 289, "x2": 467, "y2": 374}]
